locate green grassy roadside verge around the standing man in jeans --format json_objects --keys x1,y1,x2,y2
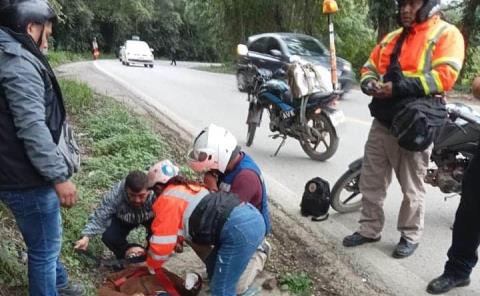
[{"x1": 0, "y1": 80, "x2": 191, "y2": 295}]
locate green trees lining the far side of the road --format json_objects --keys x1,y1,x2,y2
[{"x1": 50, "y1": 0, "x2": 480, "y2": 84}]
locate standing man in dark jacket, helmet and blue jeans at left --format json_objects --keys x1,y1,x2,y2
[{"x1": 0, "y1": 0, "x2": 85, "y2": 296}]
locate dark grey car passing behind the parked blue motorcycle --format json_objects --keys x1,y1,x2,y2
[{"x1": 237, "y1": 33, "x2": 354, "y2": 92}]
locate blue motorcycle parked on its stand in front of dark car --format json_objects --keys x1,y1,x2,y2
[{"x1": 246, "y1": 65, "x2": 345, "y2": 161}]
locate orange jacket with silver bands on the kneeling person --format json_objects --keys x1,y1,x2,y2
[{"x1": 147, "y1": 185, "x2": 209, "y2": 269}]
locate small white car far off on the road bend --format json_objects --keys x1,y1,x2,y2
[{"x1": 120, "y1": 40, "x2": 154, "y2": 68}]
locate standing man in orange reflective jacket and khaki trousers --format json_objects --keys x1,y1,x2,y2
[{"x1": 343, "y1": 0, "x2": 464, "y2": 258}]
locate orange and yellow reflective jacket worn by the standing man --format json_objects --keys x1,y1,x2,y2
[{"x1": 361, "y1": 16, "x2": 465, "y2": 97}]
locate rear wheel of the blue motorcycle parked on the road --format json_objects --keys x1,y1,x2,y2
[{"x1": 300, "y1": 114, "x2": 339, "y2": 161}]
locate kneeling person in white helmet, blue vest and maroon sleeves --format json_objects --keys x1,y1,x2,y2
[{"x1": 188, "y1": 124, "x2": 271, "y2": 295}]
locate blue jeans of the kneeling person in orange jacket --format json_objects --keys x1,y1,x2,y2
[{"x1": 206, "y1": 203, "x2": 265, "y2": 296}]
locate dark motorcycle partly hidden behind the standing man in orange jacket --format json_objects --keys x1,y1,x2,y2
[{"x1": 330, "y1": 103, "x2": 480, "y2": 213}]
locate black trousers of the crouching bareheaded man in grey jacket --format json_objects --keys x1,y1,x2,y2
[{"x1": 102, "y1": 217, "x2": 153, "y2": 259}]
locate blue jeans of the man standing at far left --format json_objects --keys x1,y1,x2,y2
[{"x1": 0, "y1": 186, "x2": 68, "y2": 296}]
